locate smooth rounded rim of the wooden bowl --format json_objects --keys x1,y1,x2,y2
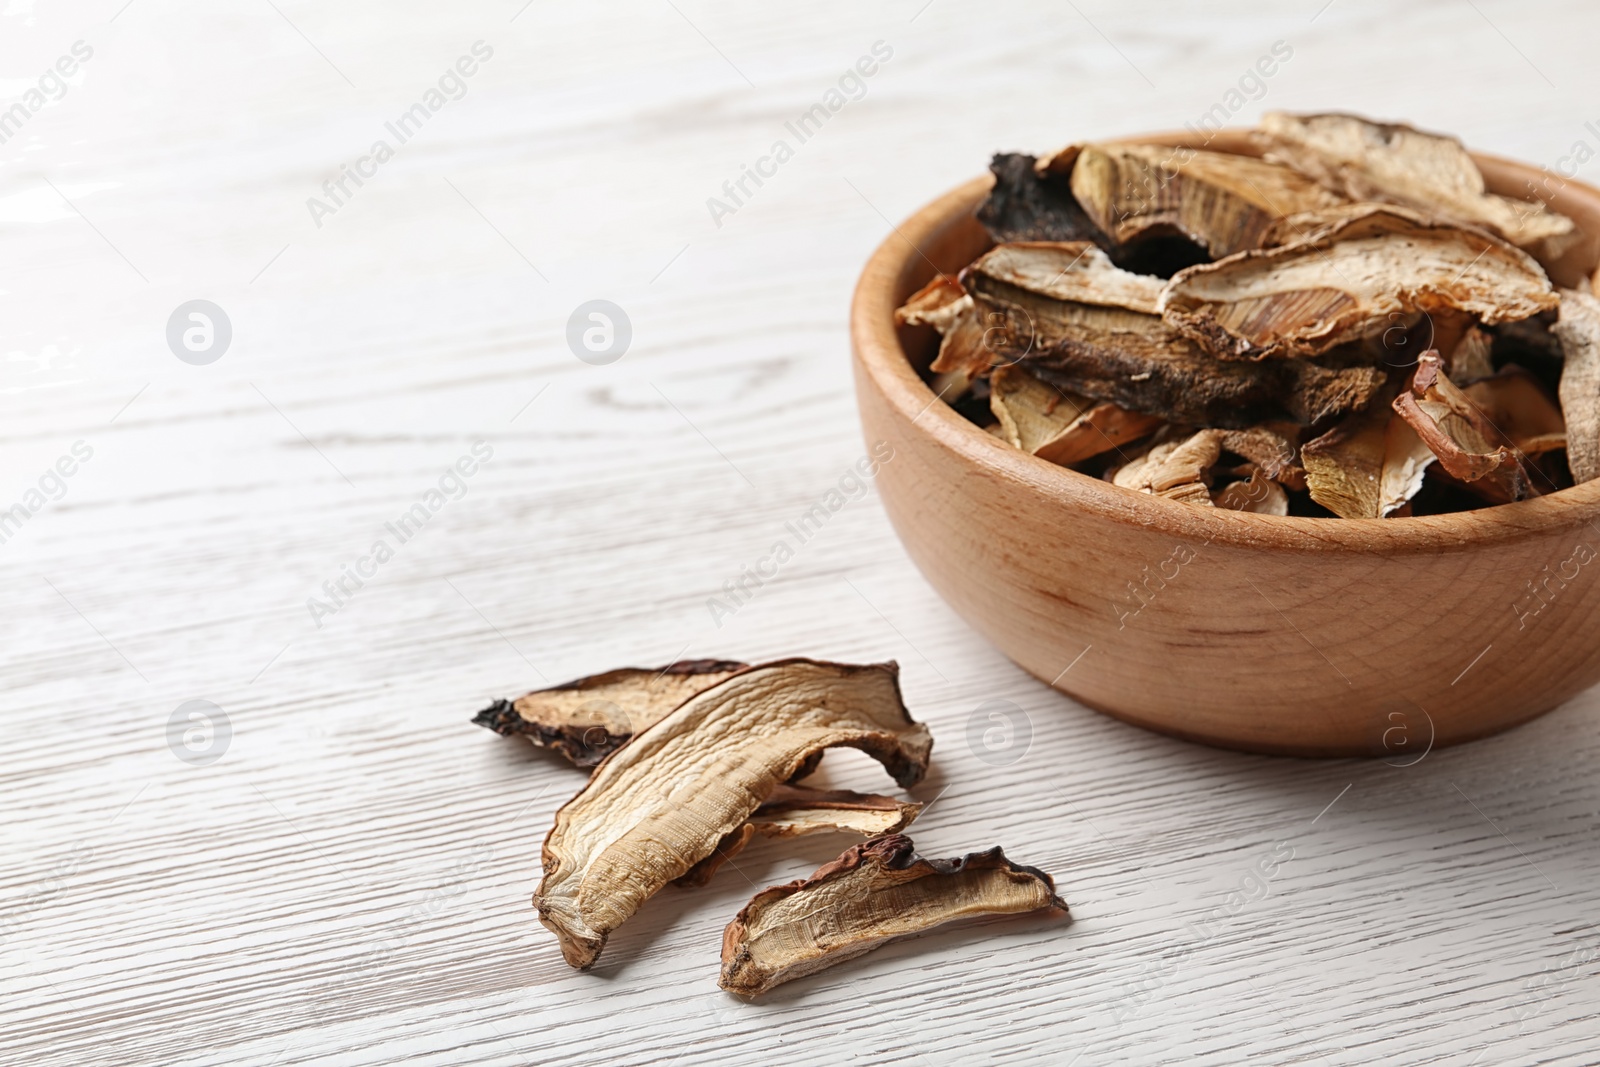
[{"x1": 850, "y1": 128, "x2": 1600, "y2": 553}]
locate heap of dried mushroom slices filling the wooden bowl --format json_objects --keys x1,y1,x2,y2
[{"x1": 896, "y1": 114, "x2": 1600, "y2": 518}]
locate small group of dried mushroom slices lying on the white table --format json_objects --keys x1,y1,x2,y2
[{"x1": 474, "y1": 659, "x2": 1067, "y2": 995}]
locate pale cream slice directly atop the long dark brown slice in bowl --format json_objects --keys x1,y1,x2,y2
[{"x1": 963, "y1": 242, "x2": 1165, "y2": 315}]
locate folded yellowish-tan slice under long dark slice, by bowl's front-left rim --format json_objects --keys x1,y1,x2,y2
[{"x1": 989, "y1": 366, "x2": 1162, "y2": 467}]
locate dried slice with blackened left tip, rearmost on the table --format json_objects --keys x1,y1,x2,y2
[{"x1": 472, "y1": 659, "x2": 746, "y2": 766}]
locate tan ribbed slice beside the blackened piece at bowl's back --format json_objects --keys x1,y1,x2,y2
[{"x1": 1072, "y1": 144, "x2": 1344, "y2": 258}]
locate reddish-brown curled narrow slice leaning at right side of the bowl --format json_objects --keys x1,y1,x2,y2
[{"x1": 1394, "y1": 352, "x2": 1536, "y2": 504}]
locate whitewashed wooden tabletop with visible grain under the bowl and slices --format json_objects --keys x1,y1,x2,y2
[{"x1": 0, "y1": 0, "x2": 1600, "y2": 1067}]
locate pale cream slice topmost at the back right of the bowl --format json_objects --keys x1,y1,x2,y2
[{"x1": 1256, "y1": 112, "x2": 1579, "y2": 262}]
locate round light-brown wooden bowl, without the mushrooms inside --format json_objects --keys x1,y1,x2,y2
[{"x1": 851, "y1": 131, "x2": 1600, "y2": 761}]
